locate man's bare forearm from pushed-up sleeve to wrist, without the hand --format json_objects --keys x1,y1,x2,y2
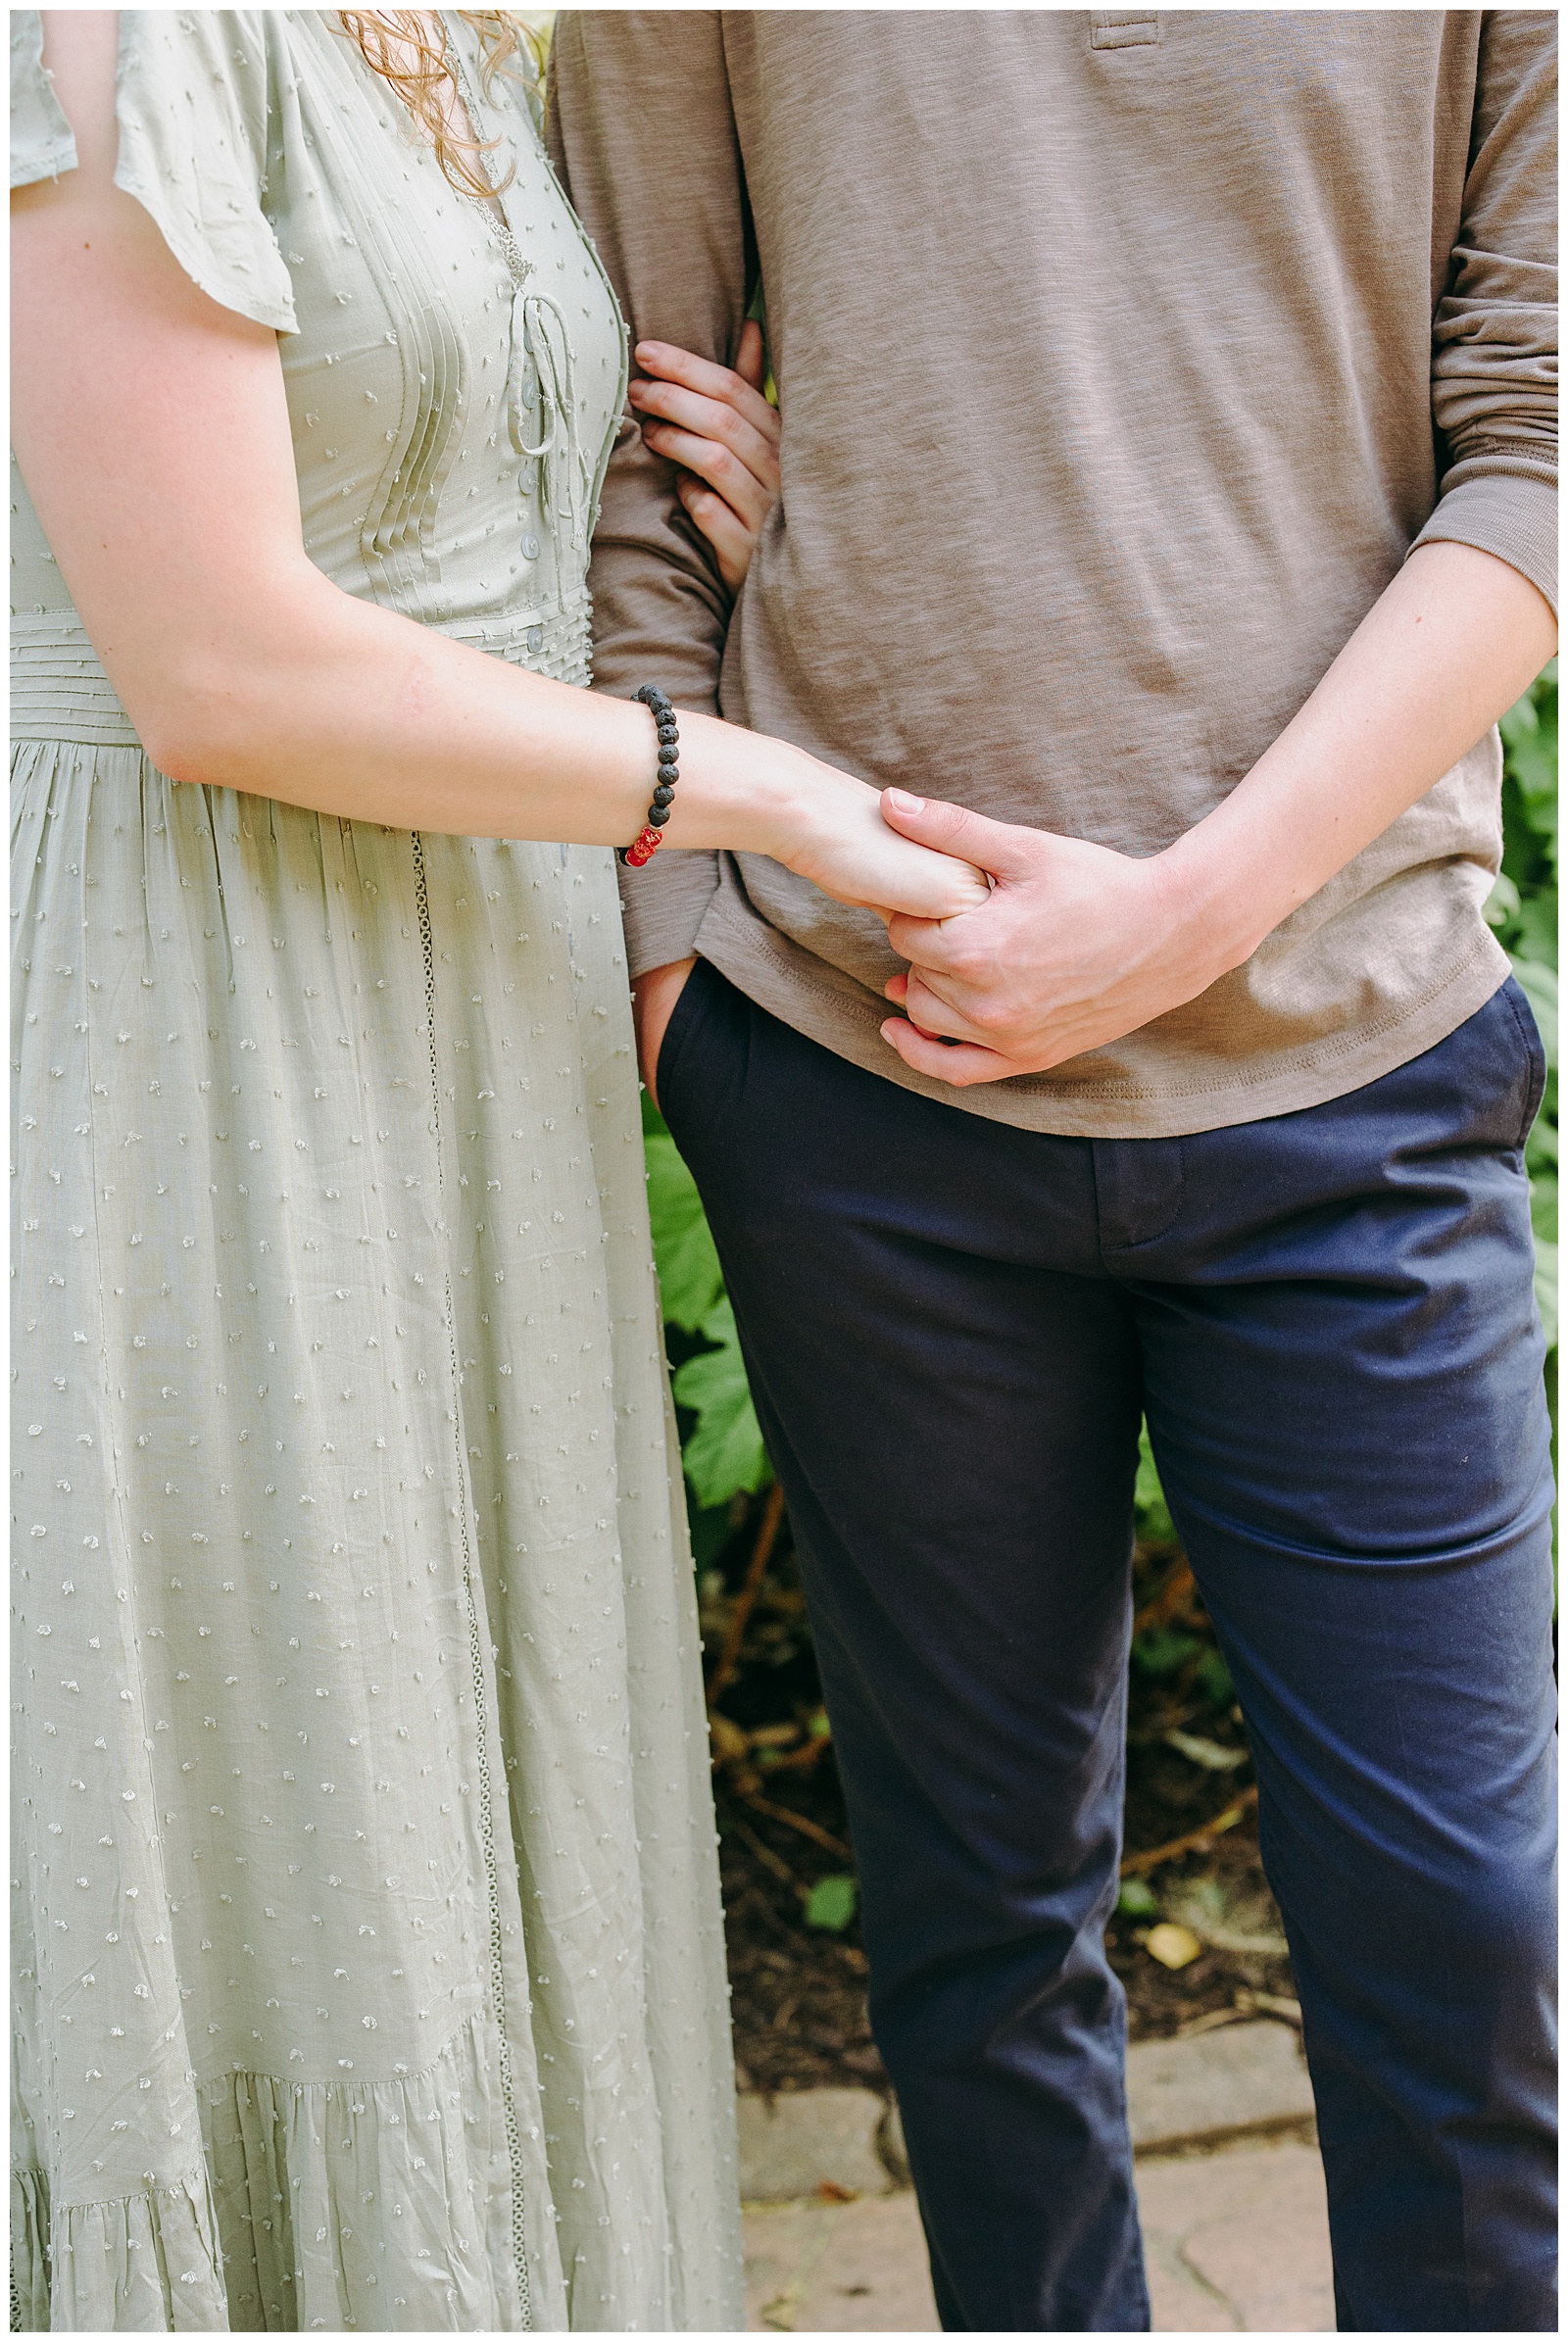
[{"x1": 1162, "y1": 543, "x2": 1556, "y2": 974}]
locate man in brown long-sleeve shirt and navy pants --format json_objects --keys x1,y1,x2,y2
[{"x1": 553, "y1": 10, "x2": 1556, "y2": 2330}]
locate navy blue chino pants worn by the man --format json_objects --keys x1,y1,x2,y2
[{"x1": 659, "y1": 962, "x2": 1556, "y2": 2332}]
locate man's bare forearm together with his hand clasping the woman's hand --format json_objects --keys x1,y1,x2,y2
[{"x1": 881, "y1": 541, "x2": 1556, "y2": 1089}]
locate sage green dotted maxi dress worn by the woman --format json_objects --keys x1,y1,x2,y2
[{"x1": 12, "y1": 10, "x2": 741, "y2": 2332}]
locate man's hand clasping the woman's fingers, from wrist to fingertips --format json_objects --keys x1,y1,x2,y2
[{"x1": 866, "y1": 789, "x2": 1218, "y2": 1089}]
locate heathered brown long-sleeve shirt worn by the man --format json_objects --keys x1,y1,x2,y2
[{"x1": 551, "y1": 10, "x2": 1556, "y2": 1139}]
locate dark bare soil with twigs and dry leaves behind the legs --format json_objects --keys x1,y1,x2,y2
[{"x1": 699, "y1": 1496, "x2": 1294, "y2": 2091}]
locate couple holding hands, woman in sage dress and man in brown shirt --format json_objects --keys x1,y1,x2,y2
[{"x1": 12, "y1": 10, "x2": 1556, "y2": 2332}]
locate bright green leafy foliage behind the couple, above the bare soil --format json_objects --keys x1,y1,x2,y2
[{"x1": 642, "y1": 660, "x2": 1556, "y2": 1543}]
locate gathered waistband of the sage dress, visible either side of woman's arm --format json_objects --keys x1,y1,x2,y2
[{"x1": 12, "y1": 593, "x2": 593, "y2": 747}]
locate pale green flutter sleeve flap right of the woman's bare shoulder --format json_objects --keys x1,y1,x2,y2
[{"x1": 115, "y1": 10, "x2": 295, "y2": 332}]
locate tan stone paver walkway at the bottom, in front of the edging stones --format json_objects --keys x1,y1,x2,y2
[{"x1": 746, "y1": 2138, "x2": 1334, "y2": 2332}]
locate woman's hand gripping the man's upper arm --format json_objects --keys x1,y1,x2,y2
[{"x1": 626, "y1": 318, "x2": 778, "y2": 593}]
